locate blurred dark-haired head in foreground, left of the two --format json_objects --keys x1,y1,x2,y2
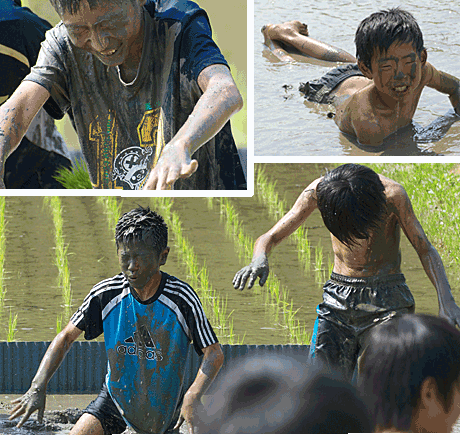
[{"x1": 198, "y1": 353, "x2": 374, "y2": 434}]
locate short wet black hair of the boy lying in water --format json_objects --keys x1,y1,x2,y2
[{"x1": 355, "y1": 8, "x2": 424, "y2": 69}]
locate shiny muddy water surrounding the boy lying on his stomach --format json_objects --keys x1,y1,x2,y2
[{"x1": 254, "y1": 0, "x2": 460, "y2": 156}]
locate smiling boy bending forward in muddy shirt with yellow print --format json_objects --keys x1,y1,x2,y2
[{"x1": 0, "y1": 0, "x2": 246, "y2": 190}]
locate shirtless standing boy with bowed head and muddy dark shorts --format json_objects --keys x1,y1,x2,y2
[{"x1": 233, "y1": 164, "x2": 460, "y2": 378}]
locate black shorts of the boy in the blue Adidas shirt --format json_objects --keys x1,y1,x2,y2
[{"x1": 84, "y1": 382, "x2": 183, "y2": 435}]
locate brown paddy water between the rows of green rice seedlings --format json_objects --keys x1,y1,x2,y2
[{"x1": 0, "y1": 164, "x2": 460, "y2": 434}]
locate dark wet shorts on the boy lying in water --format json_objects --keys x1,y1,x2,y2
[{"x1": 299, "y1": 64, "x2": 364, "y2": 104}]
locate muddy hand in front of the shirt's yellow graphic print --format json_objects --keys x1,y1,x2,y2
[{"x1": 142, "y1": 145, "x2": 198, "y2": 190}]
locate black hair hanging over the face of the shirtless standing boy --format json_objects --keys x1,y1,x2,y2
[{"x1": 316, "y1": 164, "x2": 386, "y2": 246}]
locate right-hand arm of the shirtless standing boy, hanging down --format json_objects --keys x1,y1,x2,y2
[{"x1": 388, "y1": 182, "x2": 460, "y2": 325}]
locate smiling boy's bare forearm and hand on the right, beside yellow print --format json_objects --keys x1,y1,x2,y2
[{"x1": 143, "y1": 64, "x2": 243, "y2": 190}]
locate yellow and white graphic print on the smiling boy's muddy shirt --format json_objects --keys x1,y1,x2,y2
[{"x1": 89, "y1": 108, "x2": 165, "y2": 190}]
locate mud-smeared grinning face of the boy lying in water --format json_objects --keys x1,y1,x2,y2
[{"x1": 360, "y1": 42, "x2": 426, "y2": 101}]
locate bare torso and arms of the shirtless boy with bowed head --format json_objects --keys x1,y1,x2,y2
[{"x1": 233, "y1": 176, "x2": 460, "y2": 324}]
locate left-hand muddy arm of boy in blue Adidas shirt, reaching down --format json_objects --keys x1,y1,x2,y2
[{"x1": 9, "y1": 322, "x2": 82, "y2": 428}]
